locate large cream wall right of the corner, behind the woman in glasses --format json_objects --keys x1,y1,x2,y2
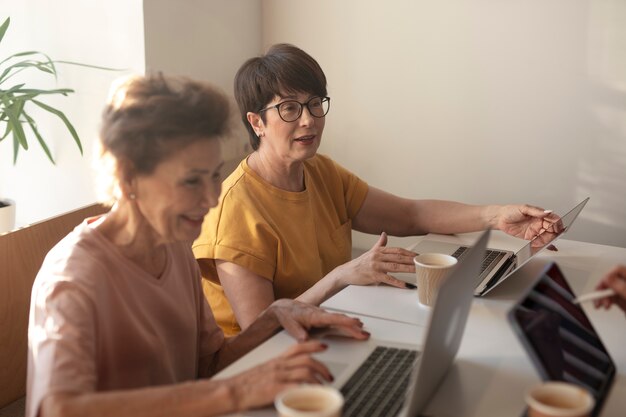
[{"x1": 263, "y1": 0, "x2": 626, "y2": 247}]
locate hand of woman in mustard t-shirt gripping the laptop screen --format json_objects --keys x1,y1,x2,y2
[{"x1": 495, "y1": 204, "x2": 563, "y2": 249}]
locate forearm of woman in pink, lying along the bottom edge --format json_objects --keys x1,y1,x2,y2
[{"x1": 39, "y1": 380, "x2": 240, "y2": 417}]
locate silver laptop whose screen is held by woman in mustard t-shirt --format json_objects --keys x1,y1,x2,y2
[{"x1": 413, "y1": 197, "x2": 589, "y2": 296}]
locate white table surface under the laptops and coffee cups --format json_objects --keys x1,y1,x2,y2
[{"x1": 216, "y1": 232, "x2": 626, "y2": 417}]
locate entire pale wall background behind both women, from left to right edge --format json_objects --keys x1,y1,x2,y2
[{"x1": 0, "y1": 0, "x2": 626, "y2": 247}]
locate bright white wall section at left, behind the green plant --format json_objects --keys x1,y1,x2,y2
[{"x1": 0, "y1": 0, "x2": 144, "y2": 226}]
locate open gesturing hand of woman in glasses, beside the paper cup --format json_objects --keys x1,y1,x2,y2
[{"x1": 333, "y1": 232, "x2": 417, "y2": 288}]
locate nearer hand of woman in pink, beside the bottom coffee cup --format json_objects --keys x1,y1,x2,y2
[{"x1": 225, "y1": 340, "x2": 333, "y2": 410}]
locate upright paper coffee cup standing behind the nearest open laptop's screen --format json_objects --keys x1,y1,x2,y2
[{"x1": 413, "y1": 253, "x2": 457, "y2": 306}]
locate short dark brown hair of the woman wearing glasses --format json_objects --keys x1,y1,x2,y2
[{"x1": 235, "y1": 43, "x2": 327, "y2": 150}]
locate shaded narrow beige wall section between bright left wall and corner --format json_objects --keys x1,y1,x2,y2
[{"x1": 144, "y1": 0, "x2": 262, "y2": 166}]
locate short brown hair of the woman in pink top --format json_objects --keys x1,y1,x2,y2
[{"x1": 100, "y1": 73, "x2": 229, "y2": 174}]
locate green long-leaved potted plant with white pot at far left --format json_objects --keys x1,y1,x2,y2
[{"x1": 0, "y1": 18, "x2": 111, "y2": 233}]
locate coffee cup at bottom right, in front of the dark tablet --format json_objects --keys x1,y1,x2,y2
[{"x1": 525, "y1": 381, "x2": 595, "y2": 417}]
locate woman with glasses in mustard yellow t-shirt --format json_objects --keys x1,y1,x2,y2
[{"x1": 193, "y1": 44, "x2": 558, "y2": 335}]
